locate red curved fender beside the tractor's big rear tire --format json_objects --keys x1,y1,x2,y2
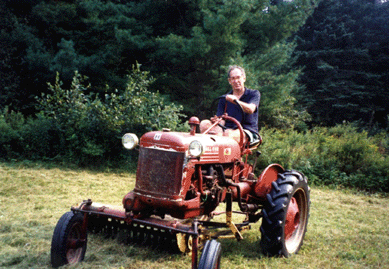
[{"x1": 254, "y1": 163, "x2": 285, "y2": 197}]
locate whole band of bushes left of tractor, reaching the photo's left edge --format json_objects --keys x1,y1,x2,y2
[{"x1": 0, "y1": 68, "x2": 187, "y2": 166}]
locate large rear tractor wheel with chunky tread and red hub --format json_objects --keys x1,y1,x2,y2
[{"x1": 261, "y1": 171, "x2": 310, "y2": 257}]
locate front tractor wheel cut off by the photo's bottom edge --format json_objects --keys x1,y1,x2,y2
[{"x1": 198, "y1": 240, "x2": 222, "y2": 269}]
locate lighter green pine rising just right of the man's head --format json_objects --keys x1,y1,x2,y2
[{"x1": 243, "y1": 1, "x2": 317, "y2": 128}]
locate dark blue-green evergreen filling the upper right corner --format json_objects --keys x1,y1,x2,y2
[{"x1": 295, "y1": 0, "x2": 389, "y2": 128}]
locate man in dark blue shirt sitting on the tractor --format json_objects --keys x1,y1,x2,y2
[{"x1": 200, "y1": 65, "x2": 261, "y2": 142}]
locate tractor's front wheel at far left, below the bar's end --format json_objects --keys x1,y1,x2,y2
[{"x1": 51, "y1": 211, "x2": 87, "y2": 267}]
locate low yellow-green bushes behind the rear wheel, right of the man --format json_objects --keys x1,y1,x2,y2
[{"x1": 261, "y1": 124, "x2": 389, "y2": 192}]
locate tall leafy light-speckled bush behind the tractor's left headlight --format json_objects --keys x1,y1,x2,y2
[{"x1": 34, "y1": 68, "x2": 182, "y2": 165}]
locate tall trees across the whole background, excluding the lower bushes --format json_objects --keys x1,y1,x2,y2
[{"x1": 0, "y1": 0, "x2": 389, "y2": 129}]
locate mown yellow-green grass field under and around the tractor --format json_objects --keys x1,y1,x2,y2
[{"x1": 0, "y1": 160, "x2": 389, "y2": 269}]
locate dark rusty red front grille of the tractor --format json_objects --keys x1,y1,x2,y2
[{"x1": 136, "y1": 148, "x2": 185, "y2": 196}]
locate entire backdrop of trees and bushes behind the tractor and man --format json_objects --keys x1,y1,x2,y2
[{"x1": 0, "y1": 0, "x2": 389, "y2": 191}]
